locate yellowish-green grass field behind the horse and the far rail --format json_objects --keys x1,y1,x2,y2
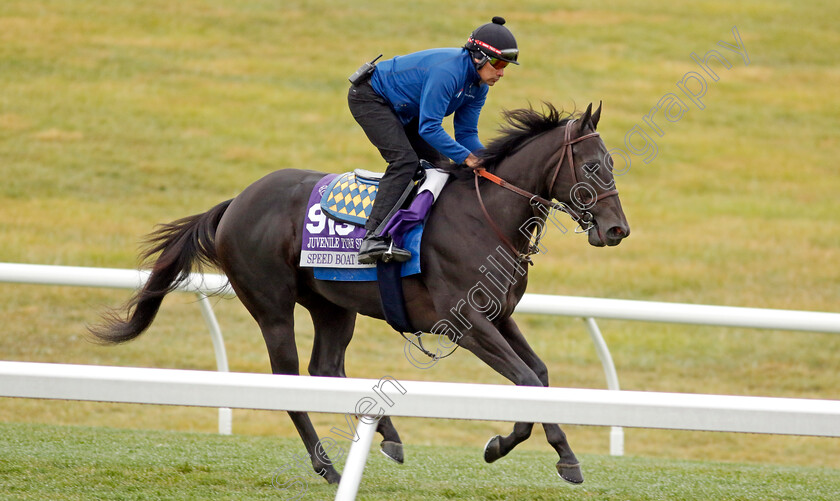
[{"x1": 0, "y1": 0, "x2": 840, "y2": 492}]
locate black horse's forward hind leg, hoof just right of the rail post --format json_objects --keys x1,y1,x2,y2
[{"x1": 301, "y1": 298, "x2": 404, "y2": 464}]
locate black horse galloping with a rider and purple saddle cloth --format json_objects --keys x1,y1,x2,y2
[{"x1": 91, "y1": 104, "x2": 630, "y2": 483}]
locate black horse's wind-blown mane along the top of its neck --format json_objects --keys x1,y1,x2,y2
[{"x1": 448, "y1": 102, "x2": 574, "y2": 177}]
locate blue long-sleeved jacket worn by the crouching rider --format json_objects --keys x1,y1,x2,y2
[{"x1": 370, "y1": 49, "x2": 489, "y2": 163}]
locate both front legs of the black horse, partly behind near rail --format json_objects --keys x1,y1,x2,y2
[{"x1": 458, "y1": 315, "x2": 583, "y2": 484}]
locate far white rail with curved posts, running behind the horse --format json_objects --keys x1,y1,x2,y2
[{"x1": 0, "y1": 263, "x2": 840, "y2": 455}]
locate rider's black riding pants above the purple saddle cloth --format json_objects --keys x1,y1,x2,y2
[{"x1": 347, "y1": 81, "x2": 446, "y2": 231}]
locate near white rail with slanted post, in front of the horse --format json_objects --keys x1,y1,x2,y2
[{"x1": 0, "y1": 362, "x2": 840, "y2": 500}]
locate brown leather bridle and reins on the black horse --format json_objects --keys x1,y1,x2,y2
[{"x1": 473, "y1": 120, "x2": 618, "y2": 264}]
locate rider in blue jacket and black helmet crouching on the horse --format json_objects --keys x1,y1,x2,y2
[{"x1": 347, "y1": 17, "x2": 519, "y2": 264}]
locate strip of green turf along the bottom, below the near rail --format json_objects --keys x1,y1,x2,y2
[{"x1": 0, "y1": 424, "x2": 840, "y2": 501}]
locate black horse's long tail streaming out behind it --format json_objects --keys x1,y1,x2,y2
[{"x1": 88, "y1": 199, "x2": 233, "y2": 344}]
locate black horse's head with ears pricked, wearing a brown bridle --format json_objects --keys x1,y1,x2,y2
[{"x1": 549, "y1": 104, "x2": 630, "y2": 247}]
